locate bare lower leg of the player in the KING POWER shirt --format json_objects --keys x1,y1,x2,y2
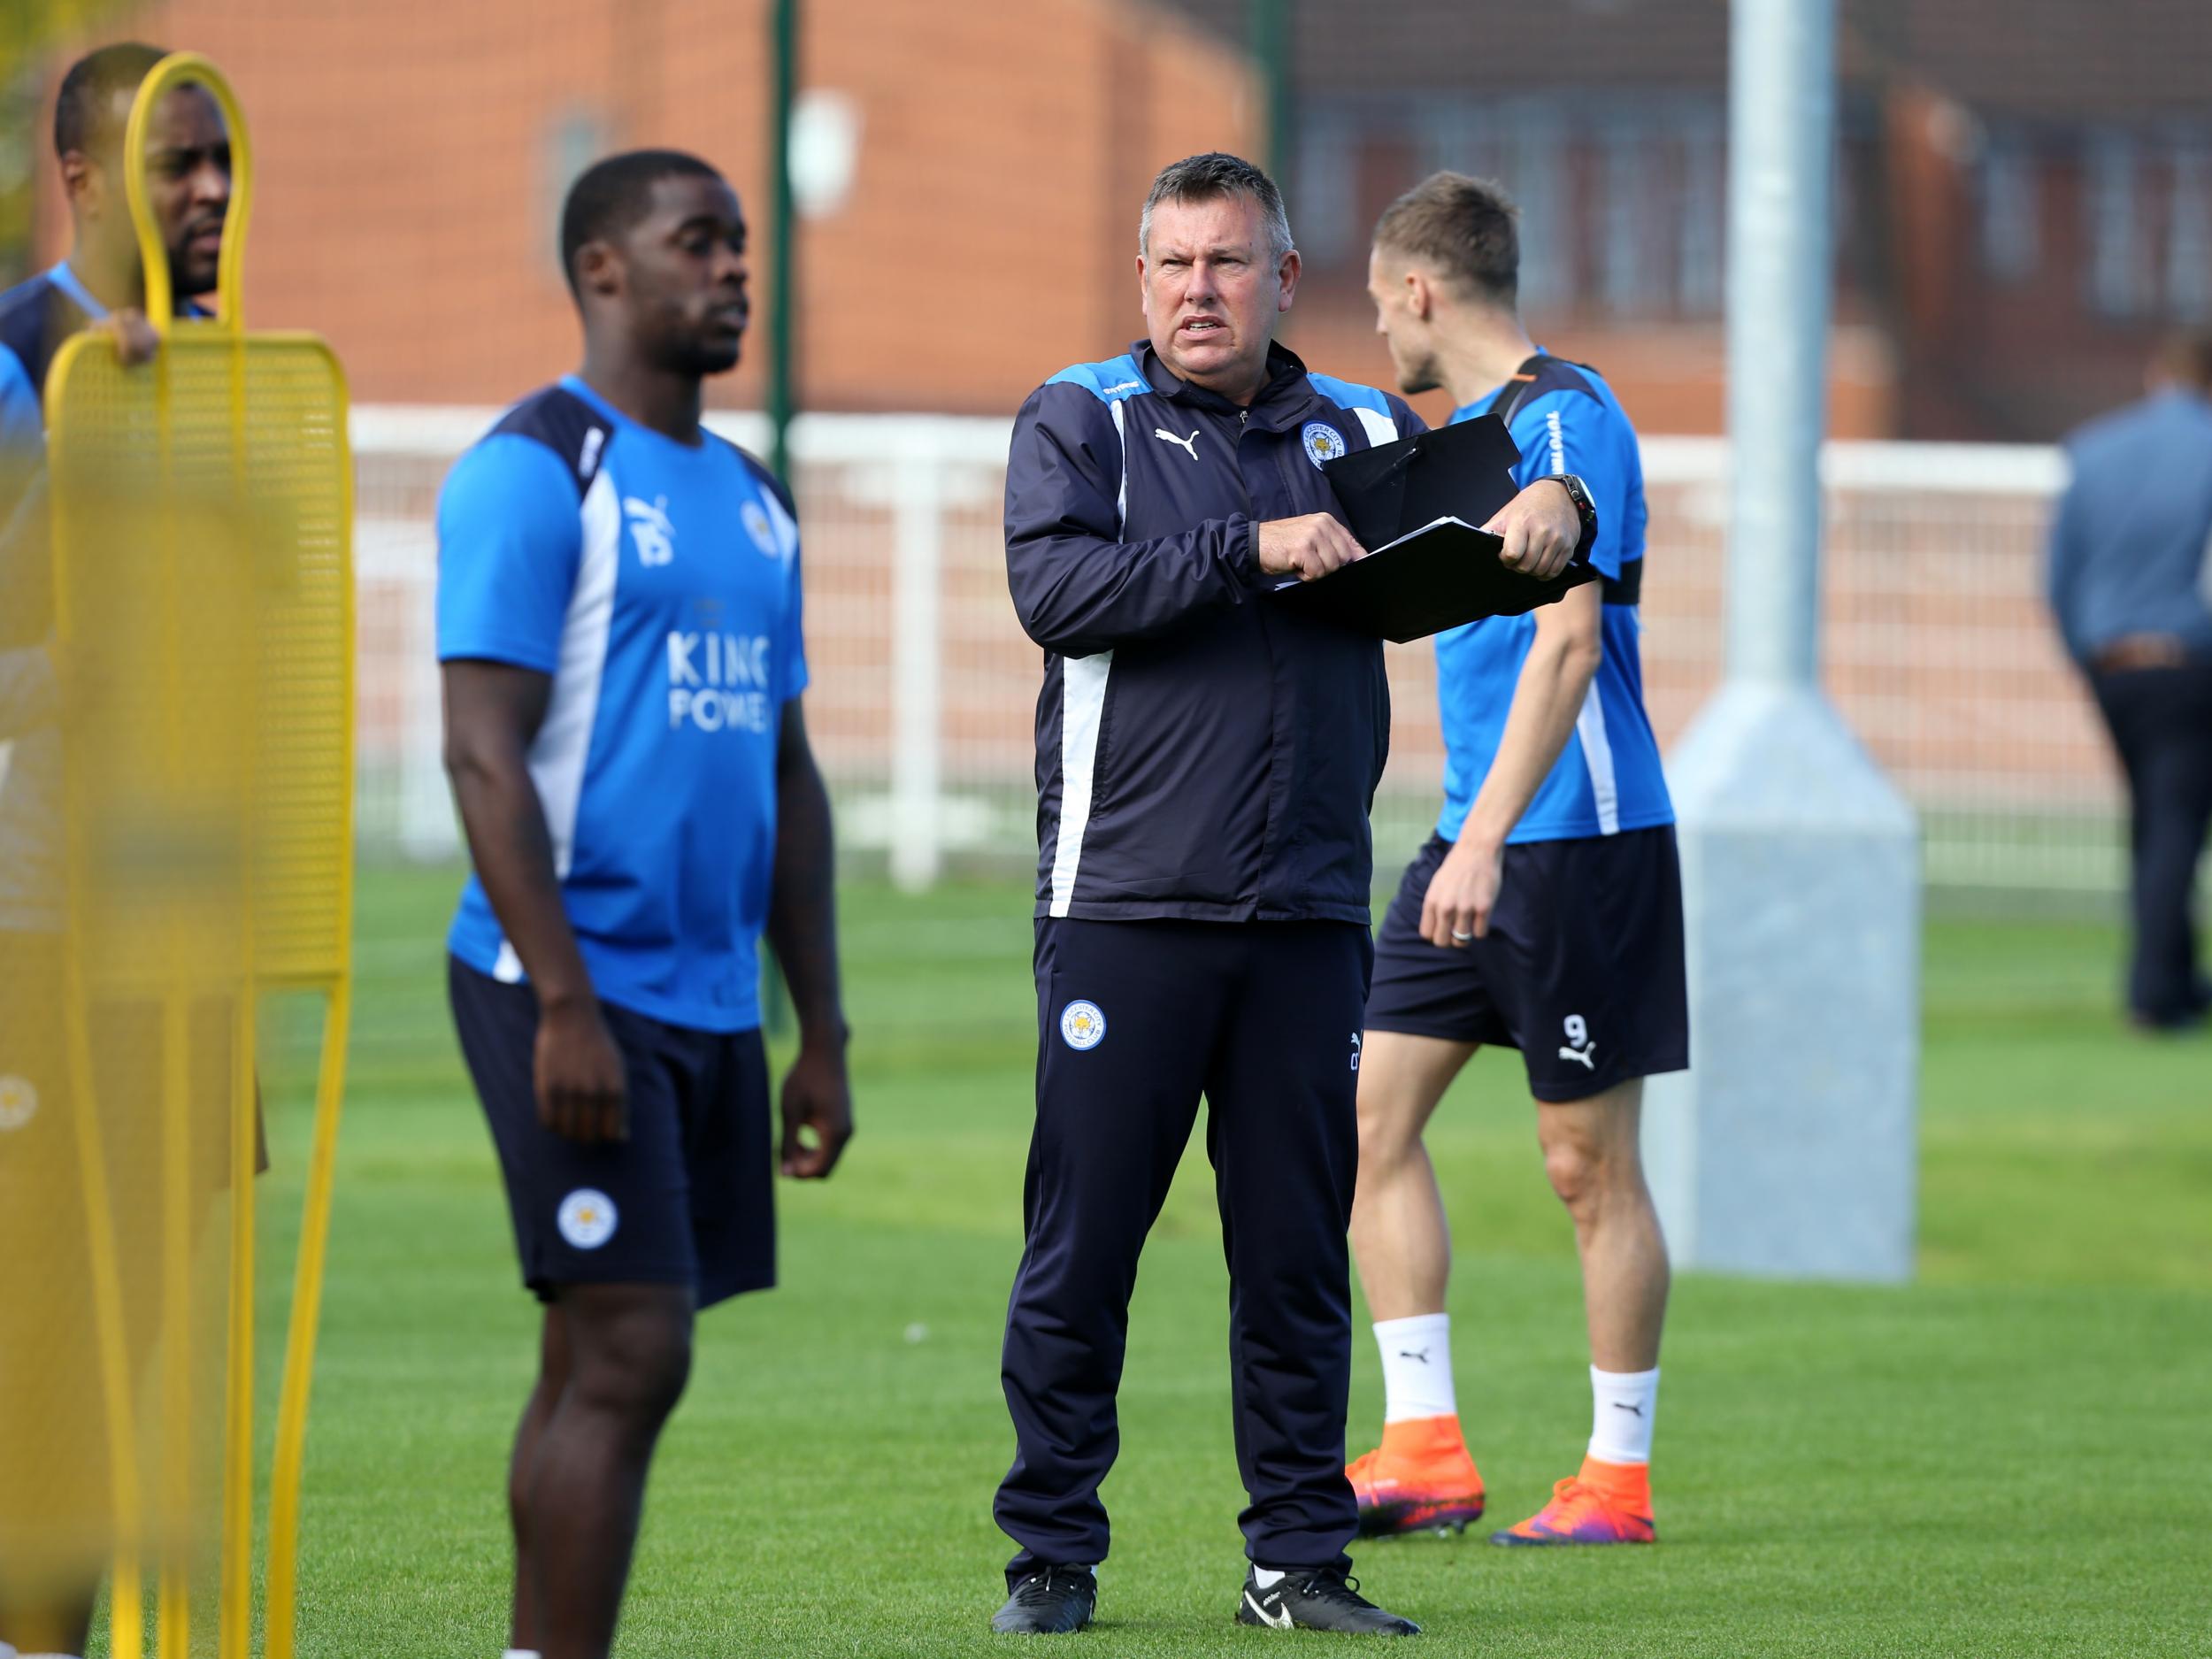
[{"x1": 516, "y1": 1286, "x2": 693, "y2": 1659}]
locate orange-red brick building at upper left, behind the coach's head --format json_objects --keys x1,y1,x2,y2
[{"x1": 17, "y1": 0, "x2": 1256, "y2": 411}]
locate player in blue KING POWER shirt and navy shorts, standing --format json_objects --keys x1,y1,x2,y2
[{"x1": 438, "y1": 150, "x2": 852, "y2": 1659}]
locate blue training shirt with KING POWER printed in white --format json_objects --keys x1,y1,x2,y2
[{"x1": 438, "y1": 376, "x2": 808, "y2": 1031}]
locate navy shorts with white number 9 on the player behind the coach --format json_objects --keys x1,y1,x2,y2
[{"x1": 1367, "y1": 826, "x2": 1690, "y2": 1102}]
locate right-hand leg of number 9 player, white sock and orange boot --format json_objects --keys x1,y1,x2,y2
[{"x1": 1495, "y1": 1079, "x2": 1671, "y2": 1544}]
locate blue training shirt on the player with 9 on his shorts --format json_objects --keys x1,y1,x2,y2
[{"x1": 1436, "y1": 352, "x2": 1675, "y2": 843}]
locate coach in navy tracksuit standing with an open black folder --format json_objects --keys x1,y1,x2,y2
[{"x1": 994, "y1": 155, "x2": 1582, "y2": 1635}]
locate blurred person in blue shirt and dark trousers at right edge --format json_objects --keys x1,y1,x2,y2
[{"x1": 2048, "y1": 330, "x2": 2212, "y2": 1031}]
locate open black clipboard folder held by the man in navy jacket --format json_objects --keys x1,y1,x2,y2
[{"x1": 1277, "y1": 416, "x2": 1597, "y2": 644}]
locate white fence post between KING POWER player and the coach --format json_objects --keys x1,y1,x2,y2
[{"x1": 889, "y1": 454, "x2": 945, "y2": 894}]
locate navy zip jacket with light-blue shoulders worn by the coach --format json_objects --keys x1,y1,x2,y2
[{"x1": 1007, "y1": 343, "x2": 1423, "y2": 923}]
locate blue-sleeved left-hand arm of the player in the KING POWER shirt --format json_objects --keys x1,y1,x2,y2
[{"x1": 438, "y1": 436, "x2": 628, "y2": 1141}]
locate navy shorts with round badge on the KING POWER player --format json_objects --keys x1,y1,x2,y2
[{"x1": 449, "y1": 958, "x2": 777, "y2": 1308}]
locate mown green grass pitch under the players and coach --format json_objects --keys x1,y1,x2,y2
[{"x1": 190, "y1": 874, "x2": 2212, "y2": 1659}]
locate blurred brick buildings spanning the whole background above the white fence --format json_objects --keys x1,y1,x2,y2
[{"x1": 17, "y1": 0, "x2": 2212, "y2": 441}]
